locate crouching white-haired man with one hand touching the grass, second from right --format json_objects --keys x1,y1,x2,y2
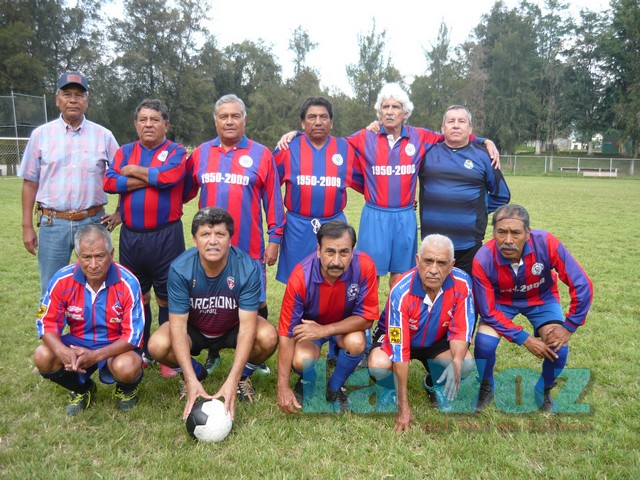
[{"x1": 369, "y1": 234, "x2": 475, "y2": 431}]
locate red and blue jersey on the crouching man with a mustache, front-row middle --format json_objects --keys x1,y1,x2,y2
[{"x1": 278, "y1": 250, "x2": 379, "y2": 337}]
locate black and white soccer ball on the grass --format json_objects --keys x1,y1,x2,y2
[{"x1": 187, "y1": 399, "x2": 232, "y2": 442}]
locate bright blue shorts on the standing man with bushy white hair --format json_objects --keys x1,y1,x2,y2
[{"x1": 358, "y1": 203, "x2": 418, "y2": 276}]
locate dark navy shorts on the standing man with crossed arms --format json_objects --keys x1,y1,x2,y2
[{"x1": 120, "y1": 220, "x2": 185, "y2": 300}]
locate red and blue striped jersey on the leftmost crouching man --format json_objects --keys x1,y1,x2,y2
[{"x1": 36, "y1": 262, "x2": 144, "y2": 347}]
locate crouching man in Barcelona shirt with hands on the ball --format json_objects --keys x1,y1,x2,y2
[{"x1": 149, "y1": 207, "x2": 278, "y2": 418}]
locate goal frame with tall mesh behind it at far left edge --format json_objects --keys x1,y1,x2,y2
[{"x1": 0, "y1": 92, "x2": 47, "y2": 176}]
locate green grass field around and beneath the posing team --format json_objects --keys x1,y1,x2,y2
[{"x1": 0, "y1": 177, "x2": 640, "y2": 479}]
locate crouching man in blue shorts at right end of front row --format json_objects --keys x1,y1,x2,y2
[{"x1": 473, "y1": 205, "x2": 593, "y2": 413}]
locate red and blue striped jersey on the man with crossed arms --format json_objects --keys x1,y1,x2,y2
[{"x1": 103, "y1": 140, "x2": 187, "y2": 230}]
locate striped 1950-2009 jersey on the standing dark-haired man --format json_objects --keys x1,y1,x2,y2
[{"x1": 273, "y1": 134, "x2": 362, "y2": 218}]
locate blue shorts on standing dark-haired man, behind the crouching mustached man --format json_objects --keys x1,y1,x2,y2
[{"x1": 276, "y1": 212, "x2": 347, "y2": 283}]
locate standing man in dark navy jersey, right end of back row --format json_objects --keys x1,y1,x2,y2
[{"x1": 419, "y1": 105, "x2": 511, "y2": 275}]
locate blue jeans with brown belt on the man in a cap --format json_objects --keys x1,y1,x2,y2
[{"x1": 38, "y1": 210, "x2": 104, "y2": 298}]
